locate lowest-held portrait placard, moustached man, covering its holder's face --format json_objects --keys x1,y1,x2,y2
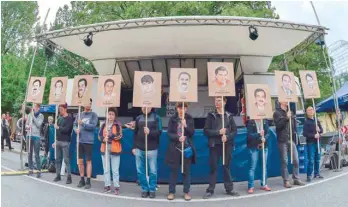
[{"x1": 246, "y1": 84, "x2": 273, "y2": 119}]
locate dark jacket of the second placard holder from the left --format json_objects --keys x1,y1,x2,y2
[{"x1": 57, "y1": 115, "x2": 74, "y2": 142}]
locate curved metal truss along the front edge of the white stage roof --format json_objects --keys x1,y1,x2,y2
[{"x1": 36, "y1": 16, "x2": 327, "y2": 41}]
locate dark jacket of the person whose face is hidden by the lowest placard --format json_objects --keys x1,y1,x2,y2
[{"x1": 247, "y1": 119, "x2": 269, "y2": 148}]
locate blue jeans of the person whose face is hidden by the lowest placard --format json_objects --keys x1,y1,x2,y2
[{"x1": 248, "y1": 148, "x2": 268, "y2": 188}]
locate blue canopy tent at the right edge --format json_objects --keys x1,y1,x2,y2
[{"x1": 316, "y1": 82, "x2": 348, "y2": 112}]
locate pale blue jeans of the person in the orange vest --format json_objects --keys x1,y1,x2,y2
[{"x1": 102, "y1": 144, "x2": 120, "y2": 188}]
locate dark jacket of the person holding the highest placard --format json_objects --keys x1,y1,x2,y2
[{"x1": 204, "y1": 111, "x2": 237, "y2": 147}]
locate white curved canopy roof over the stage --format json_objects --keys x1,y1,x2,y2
[{"x1": 37, "y1": 16, "x2": 326, "y2": 85}]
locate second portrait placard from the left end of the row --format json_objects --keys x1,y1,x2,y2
[{"x1": 49, "y1": 77, "x2": 68, "y2": 104}]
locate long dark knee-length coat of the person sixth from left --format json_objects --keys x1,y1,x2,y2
[{"x1": 165, "y1": 113, "x2": 196, "y2": 168}]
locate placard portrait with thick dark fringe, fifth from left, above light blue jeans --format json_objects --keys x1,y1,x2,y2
[{"x1": 133, "y1": 71, "x2": 162, "y2": 108}]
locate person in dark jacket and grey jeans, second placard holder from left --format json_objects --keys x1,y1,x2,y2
[{"x1": 52, "y1": 104, "x2": 73, "y2": 184}]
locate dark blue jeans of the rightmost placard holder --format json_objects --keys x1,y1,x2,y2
[{"x1": 307, "y1": 142, "x2": 321, "y2": 177}]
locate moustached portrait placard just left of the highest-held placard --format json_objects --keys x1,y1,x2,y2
[{"x1": 169, "y1": 68, "x2": 198, "y2": 102}]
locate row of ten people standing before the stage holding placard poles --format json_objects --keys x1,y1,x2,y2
[{"x1": 18, "y1": 97, "x2": 323, "y2": 201}]
